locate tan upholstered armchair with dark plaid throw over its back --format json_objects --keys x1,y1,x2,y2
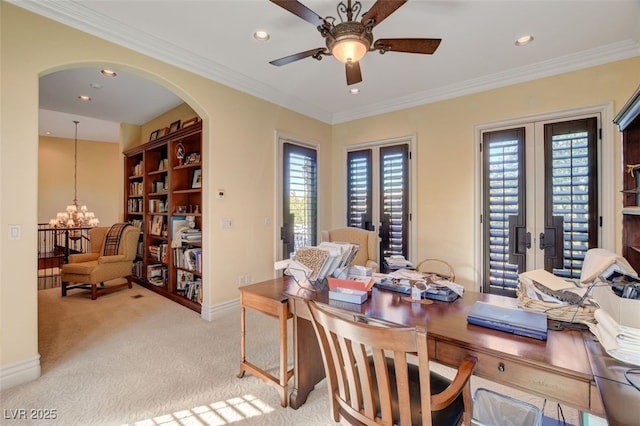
[{"x1": 62, "y1": 223, "x2": 140, "y2": 300}]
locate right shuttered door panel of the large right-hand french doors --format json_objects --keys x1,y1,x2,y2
[{"x1": 545, "y1": 118, "x2": 598, "y2": 278}]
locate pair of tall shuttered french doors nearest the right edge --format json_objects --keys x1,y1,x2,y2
[{"x1": 481, "y1": 116, "x2": 601, "y2": 295}]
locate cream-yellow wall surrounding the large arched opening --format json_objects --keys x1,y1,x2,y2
[{"x1": 0, "y1": 2, "x2": 331, "y2": 387}]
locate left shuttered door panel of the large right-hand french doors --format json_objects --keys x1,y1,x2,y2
[{"x1": 483, "y1": 129, "x2": 525, "y2": 294}]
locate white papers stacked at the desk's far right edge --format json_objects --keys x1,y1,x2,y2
[{"x1": 587, "y1": 309, "x2": 640, "y2": 365}]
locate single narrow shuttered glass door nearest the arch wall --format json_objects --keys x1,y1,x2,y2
[{"x1": 281, "y1": 143, "x2": 318, "y2": 258}]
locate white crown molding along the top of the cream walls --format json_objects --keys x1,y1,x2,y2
[{"x1": 10, "y1": 0, "x2": 640, "y2": 124}]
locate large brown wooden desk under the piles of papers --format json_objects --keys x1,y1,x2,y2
[{"x1": 243, "y1": 277, "x2": 639, "y2": 425}]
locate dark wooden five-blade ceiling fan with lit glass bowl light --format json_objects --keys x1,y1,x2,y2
[{"x1": 269, "y1": 0, "x2": 441, "y2": 85}]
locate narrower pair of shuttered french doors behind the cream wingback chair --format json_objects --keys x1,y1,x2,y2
[{"x1": 347, "y1": 143, "x2": 410, "y2": 258}]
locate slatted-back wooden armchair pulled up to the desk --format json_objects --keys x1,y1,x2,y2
[{"x1": 309, "y1": 301, "x2": 476, "y2": 426}]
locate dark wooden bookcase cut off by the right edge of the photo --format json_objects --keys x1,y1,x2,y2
[{"x1": 613, "y1": 88, "x2": 640, "y2": 272}]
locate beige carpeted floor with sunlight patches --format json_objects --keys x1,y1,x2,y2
[{"x1": 0, "y1": 286, "x2": 578, "y2": 426}]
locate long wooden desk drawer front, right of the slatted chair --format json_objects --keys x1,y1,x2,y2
[{"x1": 435, "y1": 342, "x2": 590, "y2": 410}]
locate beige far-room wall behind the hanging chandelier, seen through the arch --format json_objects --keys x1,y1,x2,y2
[{"x1": 38, "y1": 136, "x2": 123, "y2": 226}]
